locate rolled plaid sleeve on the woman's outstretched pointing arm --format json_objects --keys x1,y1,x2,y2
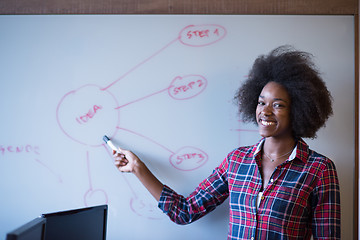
[{"x1": 158, "y1": 159, "x2": 229, "y2": 224}]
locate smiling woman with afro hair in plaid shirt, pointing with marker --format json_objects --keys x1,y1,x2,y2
[{"x1": 114, "y1": 46, "x2": 340, "y2": 240}]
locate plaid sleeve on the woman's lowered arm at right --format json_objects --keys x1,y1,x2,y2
[{"x1": 312, "y1": 159, "x2": 341, "y2": 239}]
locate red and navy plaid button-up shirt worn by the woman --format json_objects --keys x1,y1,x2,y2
[{"x1": 159, "y1": 139, "x2": 340, "y2": 240}]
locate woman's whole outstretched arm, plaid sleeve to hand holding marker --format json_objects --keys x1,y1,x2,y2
[{"x1": 114, "y1": 146, "x2": 229, "y2": 224}]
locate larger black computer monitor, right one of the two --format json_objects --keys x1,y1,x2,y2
[{"x1": 42, "y1": 205, "x2": 108, "y2": 240}]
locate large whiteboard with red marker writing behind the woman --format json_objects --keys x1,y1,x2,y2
[{"x1": 0, "y1": 15, "x2": 355, "y2": 240}]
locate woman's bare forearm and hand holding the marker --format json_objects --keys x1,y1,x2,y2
[{"x1": 113, "y1": 148, "x2": 164, "y2": 201}]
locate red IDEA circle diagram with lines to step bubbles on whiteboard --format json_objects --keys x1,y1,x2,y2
[{"x1": 56, "y1": 24, "x2": 227, "y2": 219}]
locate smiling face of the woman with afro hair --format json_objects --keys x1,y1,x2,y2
[{"x1": 256, "y1": 82, "x2": 292, "y2": 139}]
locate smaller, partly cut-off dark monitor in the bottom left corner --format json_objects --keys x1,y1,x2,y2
[{"x1": 6, "y1": 217, "x2": 46, "y2": 240}]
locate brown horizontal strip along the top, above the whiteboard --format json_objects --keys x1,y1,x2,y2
[{"x1": 0, "y1": 0, "x2": 358, "y2": 15}]
